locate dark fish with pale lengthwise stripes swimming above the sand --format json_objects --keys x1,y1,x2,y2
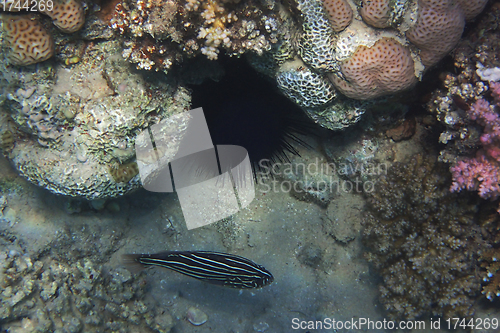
[{"x1": 123, "y1": 251, "x2": 274, "y2": 289}]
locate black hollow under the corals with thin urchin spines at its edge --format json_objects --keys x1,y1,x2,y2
[{"x1": 184, "y1": 56, "x2": 315, "y2": 168}]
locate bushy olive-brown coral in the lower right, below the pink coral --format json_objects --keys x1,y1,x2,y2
[{"x1": 363, "y1": 155, "x2": 487, "y2": 319}]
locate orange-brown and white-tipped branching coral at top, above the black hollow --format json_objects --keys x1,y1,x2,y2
[{"x1": 110, "y1": 0, "x2": 279, "y2": 71}]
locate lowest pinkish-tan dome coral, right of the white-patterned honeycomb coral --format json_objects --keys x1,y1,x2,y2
[{"x1": 329, "y1": 38, "x2": 417, "y2": 99}]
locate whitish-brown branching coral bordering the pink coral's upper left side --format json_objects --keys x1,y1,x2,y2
[{"x1": 428, "y1": 4, "x2": 500, "y2": 156}]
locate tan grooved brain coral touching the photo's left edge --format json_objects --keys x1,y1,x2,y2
[{"x1": 1, "y1": 14, "x2": 54, "y2": 66}]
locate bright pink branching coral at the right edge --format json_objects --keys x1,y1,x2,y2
[{"x1": 450, "y1": 82, "x2": 500, "y2": 200}]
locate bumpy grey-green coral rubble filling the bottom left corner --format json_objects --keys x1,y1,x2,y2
[{"x1": 0, "y1": 245, "x2": 174, "y2": 332}]
